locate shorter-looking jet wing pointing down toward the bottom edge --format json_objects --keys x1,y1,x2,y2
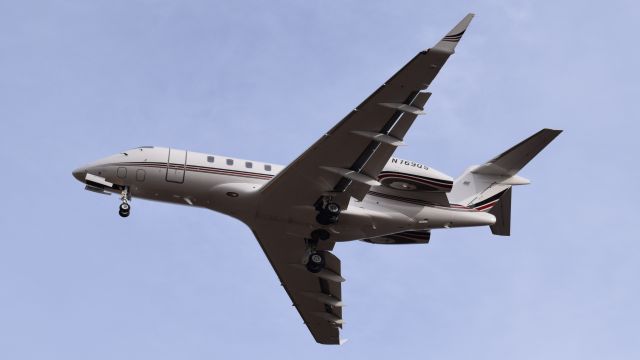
[{"x1": 252, "y1": 222, "x2": 344, "y2": 344}]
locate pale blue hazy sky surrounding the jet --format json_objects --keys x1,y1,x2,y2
[{"x1": 0, "y1": 0, "x2": 640, "y2": 359}]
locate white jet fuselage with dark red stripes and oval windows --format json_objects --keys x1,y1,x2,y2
[{"x1": 73, "y1": 147, "x2": 495, "y2": 241}]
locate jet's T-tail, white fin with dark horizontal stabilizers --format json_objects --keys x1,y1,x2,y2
[{"x1": 449, "y1": 129, "x2": 562, "y2": 236}]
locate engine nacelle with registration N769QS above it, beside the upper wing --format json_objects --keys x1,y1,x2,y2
[{"x1": 378, "y1": 158, "x2": 453, "y2": 192}]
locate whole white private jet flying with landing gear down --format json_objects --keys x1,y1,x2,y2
[{"x1": 73, "y1": 14, "x2": 562, "y2": 344}]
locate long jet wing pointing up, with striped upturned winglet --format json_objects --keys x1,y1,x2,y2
[{"x1": 261, "y1": 14, "x2": 473, "y2": 212}]
